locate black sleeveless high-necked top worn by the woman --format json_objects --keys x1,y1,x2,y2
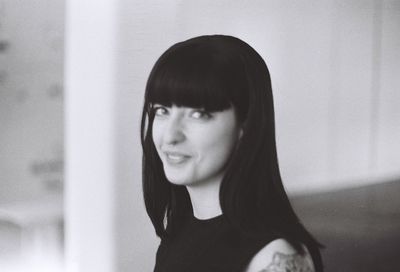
[{"x1": 154, "y1": 215, "x2": 280, "y2": 272}]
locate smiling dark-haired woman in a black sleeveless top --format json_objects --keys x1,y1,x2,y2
[{"x1": 141, "y1": 35, "x2": 322, "y2": 272}]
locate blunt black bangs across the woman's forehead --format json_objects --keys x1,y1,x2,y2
[{"x1": 146, "y1": 41, "x2": 248, "y2": 117}]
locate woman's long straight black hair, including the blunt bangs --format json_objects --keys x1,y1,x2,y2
[{"x1": 141, "y1": 35, "x2": 322, "y2": 271}]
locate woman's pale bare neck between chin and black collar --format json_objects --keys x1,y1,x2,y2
[{"x1": 186, "y1": 177, "x2": 222, "y2": 220}]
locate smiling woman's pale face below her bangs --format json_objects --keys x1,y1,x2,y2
[{"x1": 152, "y1": 104, "x2": 241, "y2": 186}]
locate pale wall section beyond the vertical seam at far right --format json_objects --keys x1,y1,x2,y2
[{"x1": 374, "y1": 0, "x2": 400, "y2": 181}]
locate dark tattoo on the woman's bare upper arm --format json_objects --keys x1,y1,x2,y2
[{"x1": 259, "y1": 252, "x2": 314, "y2": 272}]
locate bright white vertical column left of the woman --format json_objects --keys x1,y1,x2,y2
[{"x1": 65, "y1": 0, "x2": 118, "y2": 272}]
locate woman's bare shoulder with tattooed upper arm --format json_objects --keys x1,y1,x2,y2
[{"x1": 245, "y1": 239, "x2": 315, "y2": 272}]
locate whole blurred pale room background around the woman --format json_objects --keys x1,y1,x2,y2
[{"x1": 0, "y1": 0, "x2": 400, "y2": 272}]
